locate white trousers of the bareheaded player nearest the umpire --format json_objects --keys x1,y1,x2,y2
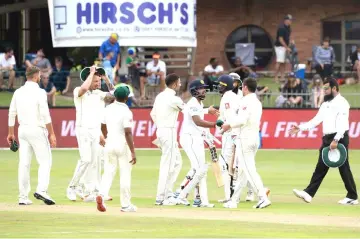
[{"x1": 234, "y1": 134, "x2": 266, "y2": 201}]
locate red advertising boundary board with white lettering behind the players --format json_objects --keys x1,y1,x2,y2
[{"x1": 0, "y1": 108, "x2": 360, "y2": 149}]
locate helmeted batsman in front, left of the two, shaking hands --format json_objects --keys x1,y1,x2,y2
[{"x1": 177, "y1": 80, "x2": 219, "y2": 207}]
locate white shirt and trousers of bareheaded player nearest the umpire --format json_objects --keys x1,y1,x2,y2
[{"x1": 230, "y1": 93, "x2": 266, "y2": 200}]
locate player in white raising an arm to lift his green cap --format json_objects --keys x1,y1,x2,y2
[{"x1": 67, "y1": 66, "x2": 114, "y2": 201}]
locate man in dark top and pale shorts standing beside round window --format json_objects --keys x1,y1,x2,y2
[{"x1": 275, "y1": 14, "x2": 293, "y2": 82}]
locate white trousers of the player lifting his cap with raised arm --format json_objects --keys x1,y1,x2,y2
[{"x1": 69, "y1": 127, "x2": 100, "y2": 188}]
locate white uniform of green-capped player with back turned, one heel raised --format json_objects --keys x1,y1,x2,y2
[{"x1": 100, "y1": 101, "x2": 133, "y2": 207}]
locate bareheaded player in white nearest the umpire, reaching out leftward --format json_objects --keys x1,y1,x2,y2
[{"x1": 222, "y1": 78, "x2": 271, "y2": 208}]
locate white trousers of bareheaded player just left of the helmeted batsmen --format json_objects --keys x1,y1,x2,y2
[{"x1": 156, "y1": 128, "x2": 182, "y2": 201}]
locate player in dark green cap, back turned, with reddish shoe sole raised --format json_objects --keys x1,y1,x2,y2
[{"x1": 96, "y1": 86, "x2": 137, "y2": 212}]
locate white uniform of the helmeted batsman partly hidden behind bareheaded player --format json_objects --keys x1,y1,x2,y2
[{"x1": 219, "y1": 91, "x2": 240, "y2": 199}]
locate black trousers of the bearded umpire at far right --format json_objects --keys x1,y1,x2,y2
[{"x1": 304, "y1": 132, "x2": 358, "y2": 200}]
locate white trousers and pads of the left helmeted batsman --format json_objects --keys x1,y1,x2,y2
[{"x1": 180, "y1": 134, "x2": 209, "y2": 204}]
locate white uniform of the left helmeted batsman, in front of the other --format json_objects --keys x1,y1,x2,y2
[{"x1": 179, "y1": 97, "x2": 209, "y2": 205}]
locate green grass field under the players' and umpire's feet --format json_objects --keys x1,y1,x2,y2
[{"x1": 0, "y1": 150, "x2": 360, "y2": 238}]
